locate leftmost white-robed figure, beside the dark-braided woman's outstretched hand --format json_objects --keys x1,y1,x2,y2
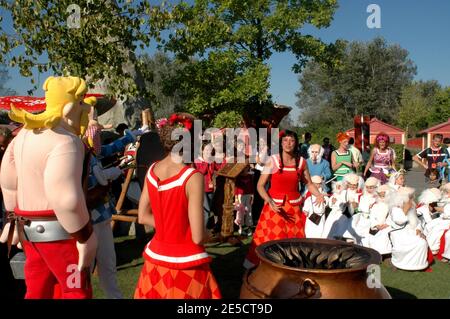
[{"x1": 303, "y1": 175, "x2": 329, "y2": 238}]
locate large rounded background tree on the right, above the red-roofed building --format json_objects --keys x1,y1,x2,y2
[{"x1": 297, "y1": 38, "x2": 416, "y2": 133}]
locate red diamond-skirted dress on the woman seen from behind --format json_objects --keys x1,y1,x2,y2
[{"x1": 134, "y1": 163, "x2": 221, "y2": 299}]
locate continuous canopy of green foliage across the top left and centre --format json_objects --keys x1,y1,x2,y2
[{"x1": 0, "y1": 0, "x2": 339, "y2": 129}]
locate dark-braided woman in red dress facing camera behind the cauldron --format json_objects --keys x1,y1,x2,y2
[{"x1": 244, "y1": 130, "x2": 324, "y2": 268}]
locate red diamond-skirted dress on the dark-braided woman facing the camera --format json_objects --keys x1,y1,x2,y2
[{"x1": 244, "y1": 155, "x2": 306, "y2": 268}]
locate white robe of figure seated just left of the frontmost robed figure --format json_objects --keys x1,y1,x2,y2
[{"x1": 369, "y1": 201, "x2": 392, "y2": 255}]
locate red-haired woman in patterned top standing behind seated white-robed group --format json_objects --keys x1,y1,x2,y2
[{"x1": 364, "y1": 133, "x2": 395, "y2": 185}]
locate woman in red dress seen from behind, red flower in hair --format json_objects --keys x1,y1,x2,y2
[{"x1": 134, "y1": 115, "x2": 221, "y2": 299}]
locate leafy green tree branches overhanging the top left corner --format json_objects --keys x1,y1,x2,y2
[{"x1": 0, "y1": 0, "x2": 153, "y2": 127}]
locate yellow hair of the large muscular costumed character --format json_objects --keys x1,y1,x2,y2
[{"x1": 9, "y1": 76, "x2": 87, "y2": 129}]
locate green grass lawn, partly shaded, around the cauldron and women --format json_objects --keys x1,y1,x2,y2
[{"x1": 93, "y1": 232, "x2": 450, "y2": 299}]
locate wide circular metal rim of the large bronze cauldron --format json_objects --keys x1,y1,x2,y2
[{"x1": 256, "y1": 238, "x2": 381, "y2": 274}]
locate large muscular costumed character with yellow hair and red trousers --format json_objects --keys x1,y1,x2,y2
[{"x1": 0, "y1": 77, "x2": 97, "y2": 299}]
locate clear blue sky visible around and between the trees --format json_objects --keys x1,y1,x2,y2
[{"x1": 3, "y1": 0, "x2": 450, "y2": 122}]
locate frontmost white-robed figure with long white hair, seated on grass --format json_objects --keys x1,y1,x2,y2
[{"x1": 390, "y1": 187, "x2": 428, "y2": 270}]
